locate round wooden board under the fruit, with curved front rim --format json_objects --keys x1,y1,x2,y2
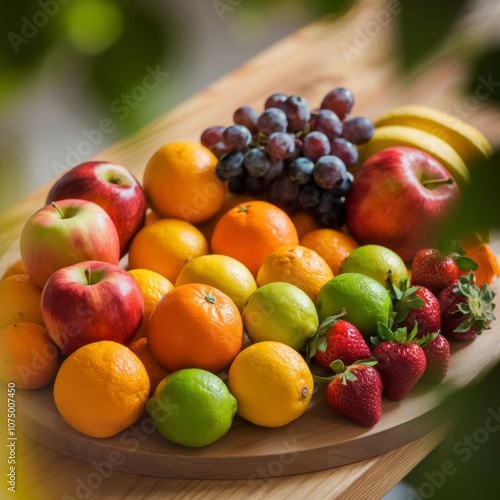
[{"x1": 3, "y1": 266, "x2": 500, "y2": 479}]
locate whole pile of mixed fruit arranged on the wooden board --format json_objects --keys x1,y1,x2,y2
[{"x1": 0, "y1": 88, "x2": 500, "y2": 458}]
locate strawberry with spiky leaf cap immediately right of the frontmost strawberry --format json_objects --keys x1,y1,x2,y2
[{"x1": 372, "y1": 322, "x2": 437, "y2": 401}]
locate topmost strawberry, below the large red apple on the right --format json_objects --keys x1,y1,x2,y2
[{"x1": 411, "y1": 240, "x2": 477, "y2": 295}]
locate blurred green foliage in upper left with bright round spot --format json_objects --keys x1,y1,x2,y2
[{"x1": 0, "y1": 0, "x2": 185, "y2": 134}]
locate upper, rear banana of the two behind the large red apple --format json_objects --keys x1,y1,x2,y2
[{"x1": 375, "y1": 104, "x2": 492, "y2": 166}]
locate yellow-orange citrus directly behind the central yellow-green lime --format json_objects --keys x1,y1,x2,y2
[{"x1": 257, "y1": 245, "x2": 333, "y2": 302}]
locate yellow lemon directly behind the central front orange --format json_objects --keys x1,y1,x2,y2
[{"x1": 175, "y1": 254, "x2": 257, "y2": 312}]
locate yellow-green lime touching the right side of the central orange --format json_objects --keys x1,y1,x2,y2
[{"x1": 242, "y1": 281, "x2": 318, "y2": 351}]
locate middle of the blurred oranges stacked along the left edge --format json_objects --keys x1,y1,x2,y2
[{"x1": 0, "y1": 274, "x2": 44, "y2": 328}]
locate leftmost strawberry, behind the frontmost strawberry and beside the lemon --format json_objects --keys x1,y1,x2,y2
[{"x1": 306, "y1": 311, "x2": 372, "y2": 372}]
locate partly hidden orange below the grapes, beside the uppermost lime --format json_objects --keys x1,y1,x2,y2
[{"x1": 300, "y1": 228, "x2": 358, "y2": 275}]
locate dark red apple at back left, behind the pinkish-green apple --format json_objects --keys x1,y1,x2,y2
[{"x1": 46, "y1": 161, "x2": 146, "y2": 257}]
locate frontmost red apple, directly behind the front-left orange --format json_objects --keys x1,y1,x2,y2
[{"x1": 41, "y1": 261, "x2": 144, "y2": 354}]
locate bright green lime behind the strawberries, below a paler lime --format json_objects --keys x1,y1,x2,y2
[{"x1": 316, "y1": 273, "x2": 392, "y2": 338}]
